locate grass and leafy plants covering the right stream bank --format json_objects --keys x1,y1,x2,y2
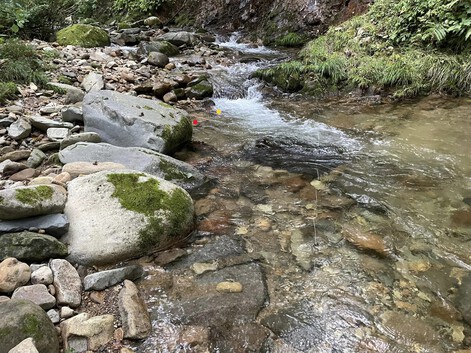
[{"x1": 255, "y1": 0, "x2": 471, "y2": 97}]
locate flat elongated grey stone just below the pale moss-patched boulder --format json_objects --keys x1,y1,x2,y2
[{"x1": 83, "y1": 265, "x2": 144, "y2": 290}]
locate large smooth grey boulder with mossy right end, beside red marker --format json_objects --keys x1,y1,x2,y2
[{"x1": 83, "y1": 91, "x2": 192, "y2": 154}]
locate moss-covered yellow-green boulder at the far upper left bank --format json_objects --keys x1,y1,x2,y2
[{"x1": 57, "y1": 24, "x2": 110, "y2": 48}]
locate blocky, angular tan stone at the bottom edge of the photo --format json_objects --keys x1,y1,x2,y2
[{"x1": 60, "y1": 313, "x2": 114, "y2": 352}]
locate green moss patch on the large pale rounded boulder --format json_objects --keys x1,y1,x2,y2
[{"x1": 107, "y1": 174, "x2": 192, "y2": 249}]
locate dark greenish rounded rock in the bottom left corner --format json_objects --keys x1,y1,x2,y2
[{"x1": 0, "y1": 299, "x2": 59, "y2": 353}]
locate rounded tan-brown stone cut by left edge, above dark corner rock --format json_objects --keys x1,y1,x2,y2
[{"x1": 0, "y1": 257, "x2": 31, "y2": 293}]
